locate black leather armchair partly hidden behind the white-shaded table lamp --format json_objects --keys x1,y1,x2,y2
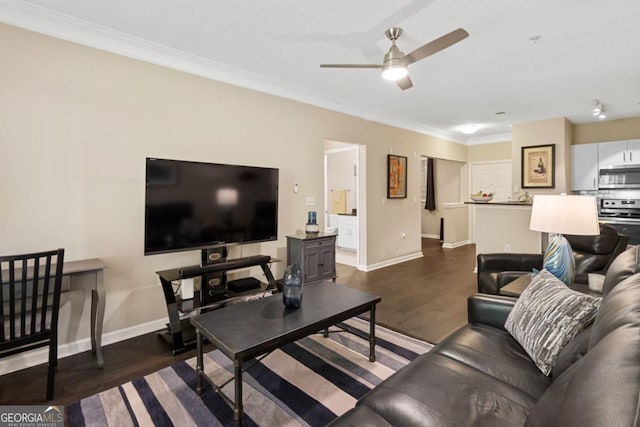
[{"x1": 477, "y1": 223, "x2": 629, "y2": 295}]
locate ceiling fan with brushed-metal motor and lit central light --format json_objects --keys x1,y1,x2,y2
[{"x1": 320, "y1": 27, "x2": 469, "y2": 90}]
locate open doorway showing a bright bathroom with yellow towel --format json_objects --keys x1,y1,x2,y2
[{"x1": 323, "y1": 140, "x2": 366, "y2": 270}]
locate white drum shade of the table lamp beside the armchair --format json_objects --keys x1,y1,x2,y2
[{"x1": 529, "y1": 194, "x2": 600, "y2": 236}]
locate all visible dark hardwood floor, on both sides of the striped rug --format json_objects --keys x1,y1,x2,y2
[{"x1": 0, "y1": 239, "x2": 476, "y2": 405}]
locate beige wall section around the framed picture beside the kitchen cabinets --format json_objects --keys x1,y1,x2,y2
[{"x1": 511, "y1": 117, "x2": 573, "y2": 194}]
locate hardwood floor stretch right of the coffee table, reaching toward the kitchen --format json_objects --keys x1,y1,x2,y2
[{"x1": 337, "y1": 239, "x2": 477, "y2": 343}]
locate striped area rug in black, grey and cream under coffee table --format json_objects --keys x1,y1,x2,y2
[{"x1": 67, "y1": 318, "x2": 433, "y2": 427}]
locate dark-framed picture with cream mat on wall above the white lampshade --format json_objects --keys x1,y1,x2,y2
[{"x1": 521, "y1": 144, "x2": 556, "y2": 188}]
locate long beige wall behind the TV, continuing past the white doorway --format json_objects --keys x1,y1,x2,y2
[{"x1": 0, "y1": 25, "x2": 466, "y2": 352}]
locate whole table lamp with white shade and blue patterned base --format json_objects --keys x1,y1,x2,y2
[{"x1": 529, "y1": 194, "x2": 600, "y2": 285}]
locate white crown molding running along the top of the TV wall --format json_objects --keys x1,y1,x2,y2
[{"x1": 0, "y1": 0, "x2": 465, "y2": 145}]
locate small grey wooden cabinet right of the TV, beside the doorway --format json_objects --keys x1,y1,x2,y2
[{"x1": 287, "y1": 233, "x2": 336, "y2": 284}]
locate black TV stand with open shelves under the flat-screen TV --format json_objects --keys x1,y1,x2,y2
[{"x1": 156, "y1": 255, "x2": 278, "y2": 355}]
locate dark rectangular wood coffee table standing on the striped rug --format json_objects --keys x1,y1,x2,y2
[{"x1": 191, "y1": 283, "x2": 380, "y2": 425}]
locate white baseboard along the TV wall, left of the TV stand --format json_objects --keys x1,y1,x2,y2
[{"x1": 0, "y1": 318, "x2": 169, "y2": 375}]
